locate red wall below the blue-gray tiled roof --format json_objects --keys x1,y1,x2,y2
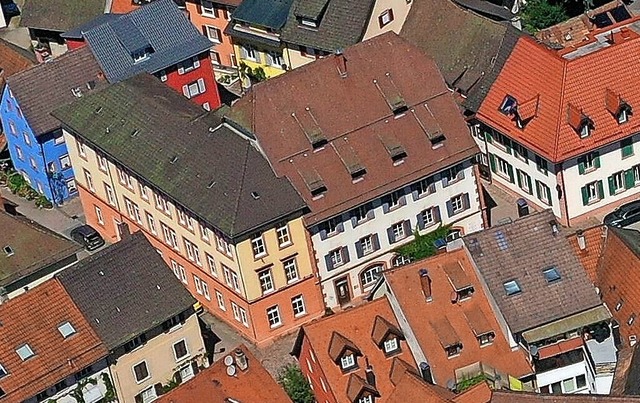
[{"x1": 156, "y1": 50, "x2": 220, "y2": 110}]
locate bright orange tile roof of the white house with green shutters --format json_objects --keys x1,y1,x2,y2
[{"x1": 477, "y1": 24, "x2": 640, "y2": 162}]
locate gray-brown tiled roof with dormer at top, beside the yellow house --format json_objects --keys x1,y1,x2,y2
[{"x1": 280, "y1": 0, "x2": 375, "y2": 52}]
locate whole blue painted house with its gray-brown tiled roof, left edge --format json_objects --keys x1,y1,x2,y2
[{"x1": 0, "y1": 47, "x2": 106, "y2": 205}]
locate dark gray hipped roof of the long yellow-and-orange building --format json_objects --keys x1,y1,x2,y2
[{"x1": 54, "y1": 74, "x2": 305, "y2": 237}]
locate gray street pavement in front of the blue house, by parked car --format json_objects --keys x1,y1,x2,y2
[{"x1": 0, "y1": 187, "x2": 85, "y2": 238}]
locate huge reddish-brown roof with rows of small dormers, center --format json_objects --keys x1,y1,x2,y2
[{"x1": 231, "y1": 33, "x2": 477, "y2": 225}]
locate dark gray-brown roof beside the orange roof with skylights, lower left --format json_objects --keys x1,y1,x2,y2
[{"x1": 57, "y1": 232, "x2": 196, "y2": 350}]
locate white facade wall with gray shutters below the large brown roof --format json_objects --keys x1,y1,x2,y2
[{"x1": 310, "y1": 162, "x2": 483, "y2": 307}]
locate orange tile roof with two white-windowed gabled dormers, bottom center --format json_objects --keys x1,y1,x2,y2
[{"x1": 294, "y1": 298, "x2": 417, "y2": 402}]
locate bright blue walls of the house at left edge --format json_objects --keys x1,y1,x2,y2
[{"x1": 0, "y1": 85, "x2": 78, "y2": 204}]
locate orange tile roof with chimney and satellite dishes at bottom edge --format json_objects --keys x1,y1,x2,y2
[{"x1": 156, "y1": 345, "x2": 291, "y2": 403}]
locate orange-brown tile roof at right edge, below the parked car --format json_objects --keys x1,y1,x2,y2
[{"x1": 596, "y1": 227, "x2": 640, "y2": 346}]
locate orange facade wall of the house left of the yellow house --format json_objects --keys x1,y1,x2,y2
[{"x1": 186, "y1": 0, "x2": 234, "y2": 66}]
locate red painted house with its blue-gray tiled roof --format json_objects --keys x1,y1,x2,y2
[{"x1": 62, "y1": 0, "x2": 220, "y2": 109}]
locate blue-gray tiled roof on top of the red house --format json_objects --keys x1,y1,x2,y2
[{"x1": 84, "y1": 0, "x2": 211, "y2": 82}]
